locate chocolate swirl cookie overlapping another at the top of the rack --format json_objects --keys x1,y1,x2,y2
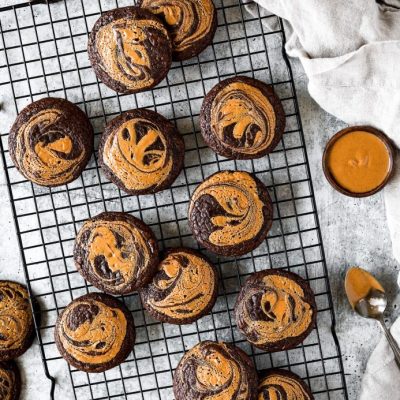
[{"x1": 88, "y1": 7, "x2": 172, "y2": 93}]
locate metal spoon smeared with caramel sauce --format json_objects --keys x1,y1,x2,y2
[{"x1": 345, "y1": 269, "x2": 400, "y2": 368}]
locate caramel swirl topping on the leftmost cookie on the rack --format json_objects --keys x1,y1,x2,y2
[{"x1": 14, "y1": 109, "x2": 85, "y2": 186}]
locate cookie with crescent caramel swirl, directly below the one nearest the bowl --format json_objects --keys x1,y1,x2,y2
[{"x1": 189, "y1": 171, "x2": 273, "y2": 256}]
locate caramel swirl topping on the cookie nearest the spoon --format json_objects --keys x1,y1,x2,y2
[{"x1": 235, "y1": 274, "x2": 313, "y2": 347}]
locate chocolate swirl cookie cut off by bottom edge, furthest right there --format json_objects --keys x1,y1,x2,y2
[{"x1": 257, "y1": 369, "x2": 314, "y2": 400}]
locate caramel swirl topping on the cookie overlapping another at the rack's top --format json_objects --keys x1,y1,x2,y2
[{"x1": 96, "y1": 17, "x2": 169, "y2": 91}]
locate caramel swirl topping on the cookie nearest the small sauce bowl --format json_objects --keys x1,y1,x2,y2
[{"x1": 210, "y1": 82, "x2": 276, "y2": 155}]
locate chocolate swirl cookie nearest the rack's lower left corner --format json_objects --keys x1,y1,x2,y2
[{"x1": 54, "y1": 293, "x2": 135, "y2": 372}]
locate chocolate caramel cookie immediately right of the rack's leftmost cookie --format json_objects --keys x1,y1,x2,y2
[{"x1": 99, "y1": 109, "x2": 185, "y2": 195}]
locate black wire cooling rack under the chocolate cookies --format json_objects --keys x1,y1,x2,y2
[{"x1": 0, "y1": 0, "x2": 347, "y2": 400}]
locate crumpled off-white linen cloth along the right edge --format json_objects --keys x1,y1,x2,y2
[{"x1": 247, "y1": 0, "x2": 400, "y2": 400}]
